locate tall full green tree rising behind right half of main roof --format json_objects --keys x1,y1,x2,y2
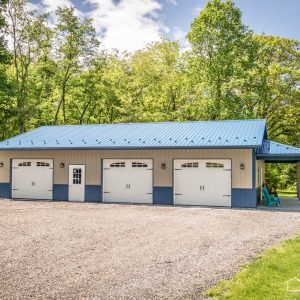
[{"x1": 187, "y1": 0, "x2": 252, "y2": 120}]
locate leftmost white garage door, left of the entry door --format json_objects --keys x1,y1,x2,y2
[{"x1": 12, "y1": 159, "x2": 53, "y2": 200}]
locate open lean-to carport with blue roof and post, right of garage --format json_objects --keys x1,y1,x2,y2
[{"x1": 256, "y1": 140, "x2": 300, "y2": 205}]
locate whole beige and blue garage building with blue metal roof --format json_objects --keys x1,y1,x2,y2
[{"x1": 0, "y1": 120, "x2": 300, "y2": 207}]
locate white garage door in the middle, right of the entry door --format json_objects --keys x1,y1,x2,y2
[{"x1": 103, "y1": 159, "x2": 153, "y2": 203}]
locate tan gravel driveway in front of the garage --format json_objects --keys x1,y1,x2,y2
[{"x1": 0, "y1": 200, "x2": 300, "y2": 300}]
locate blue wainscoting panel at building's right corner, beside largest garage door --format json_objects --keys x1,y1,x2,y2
[{"x1": 231, "y1": 189, "x2": 256, "y2": 208}]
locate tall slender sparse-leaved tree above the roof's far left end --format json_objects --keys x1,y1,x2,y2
[{"x1": 8, "y1": 0, "x2": 49, "y2": 133}]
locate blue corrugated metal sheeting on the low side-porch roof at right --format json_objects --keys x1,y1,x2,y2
[{"x1": 257, "y1": 140, "x2": 300, "y2": 156}]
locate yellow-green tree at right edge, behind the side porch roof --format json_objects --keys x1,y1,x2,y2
[{"x1": 248, "y1": 35, "x2": 300, "y2": 146}]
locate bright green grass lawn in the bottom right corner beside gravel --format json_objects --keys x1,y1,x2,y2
[{"x1": 205, "y1": 236, "x2": 300, "y2": 299}]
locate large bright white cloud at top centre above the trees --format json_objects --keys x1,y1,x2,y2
[{"x1": 86, "y1": 0, "x2": 169, "y2": 51}]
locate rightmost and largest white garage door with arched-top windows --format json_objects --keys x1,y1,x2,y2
[{"x1": 174, "y1": 159, "x2": 231, "y2": 206}]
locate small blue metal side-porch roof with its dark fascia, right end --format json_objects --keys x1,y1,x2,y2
[{"x1": 257, "y1": 140, "x2": 300, "y2": 160}]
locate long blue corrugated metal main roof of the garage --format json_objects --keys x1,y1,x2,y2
[{"x1": 0, "y1": 120, "x2": 266, "y2": 150}]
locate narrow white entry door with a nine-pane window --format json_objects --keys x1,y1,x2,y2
[{"x1": 69, "y1": 165, "x2": 85, "y2": 201}]
